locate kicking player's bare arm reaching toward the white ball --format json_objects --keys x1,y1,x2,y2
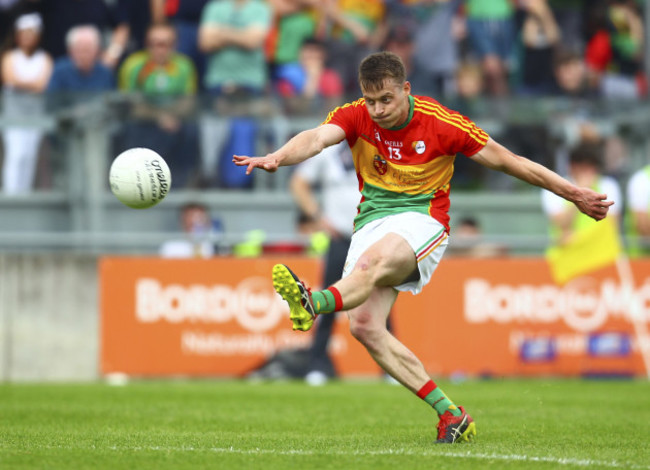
[{"x1": 232, "y1": 124, "x2": 345, "y2": 175}]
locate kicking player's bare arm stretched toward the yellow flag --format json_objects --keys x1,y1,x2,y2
[{"x1": 471, "y1": 139, "x2": 614, "y2": 220}]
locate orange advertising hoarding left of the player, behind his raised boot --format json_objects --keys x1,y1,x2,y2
[{"x1": 100, "y1": 256, "x2": 378, "y2": 376}]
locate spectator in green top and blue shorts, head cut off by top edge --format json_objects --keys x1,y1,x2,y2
[{"x1": 466, "y1": 0, "x2": 515, "y2": 96}]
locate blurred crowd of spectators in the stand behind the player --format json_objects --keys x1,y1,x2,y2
[{"x1": 0, "y1": 0, "x2": 650, "y2": 258}]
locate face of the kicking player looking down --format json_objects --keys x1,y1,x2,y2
[{"x1": 361, "y1": 80, "x2": 411, "y2": 129}]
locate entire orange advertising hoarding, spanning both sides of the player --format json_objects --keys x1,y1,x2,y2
[{"x1": 100, "y1": 256, "x2": 650, "y2": 376}]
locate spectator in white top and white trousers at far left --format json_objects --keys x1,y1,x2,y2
[{"x1": 2, "y1": 13, "x2": 52, "y2": 194}]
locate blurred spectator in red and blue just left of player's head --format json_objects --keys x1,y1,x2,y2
[{"x1": 276, "y1": 39, "x2": 343, "y2": 113}]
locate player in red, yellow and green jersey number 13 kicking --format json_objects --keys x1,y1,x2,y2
[{"x1": 233, "y1": 52, "x2": 613, "y2": 444}]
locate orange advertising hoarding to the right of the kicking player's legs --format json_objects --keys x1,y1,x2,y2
[{"x1": 398, "y1": 258, "x2": 650, "y2": 376}]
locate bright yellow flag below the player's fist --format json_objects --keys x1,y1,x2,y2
[{"x1": 546, "y1": 218, "x2": 623, "y2": 285}]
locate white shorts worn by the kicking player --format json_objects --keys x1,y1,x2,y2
[{"x1": 343, "y1": 212, "x2": 449, "y2": 294}]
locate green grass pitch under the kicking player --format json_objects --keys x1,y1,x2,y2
[{"x1": 0, "y1": 380, "x2": 650, "y2": 470}]
